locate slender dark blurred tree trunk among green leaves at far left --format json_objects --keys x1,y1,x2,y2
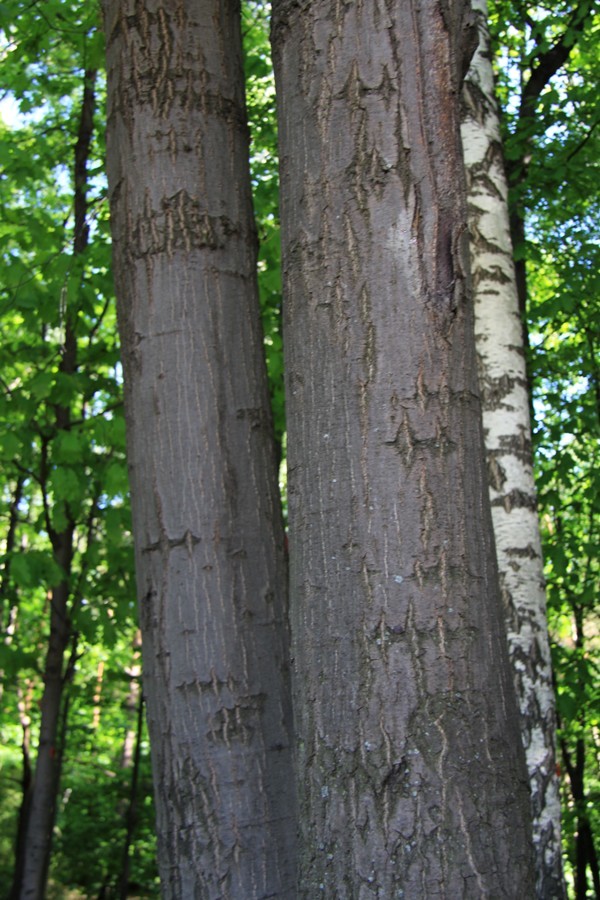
[{"x1": 9, "y1": 61, "x2": 100, "y2": 897}]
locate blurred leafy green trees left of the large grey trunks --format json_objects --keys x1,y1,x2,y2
[{"x1": 0, "y1": 3, "x2": 157, "y2": 897}]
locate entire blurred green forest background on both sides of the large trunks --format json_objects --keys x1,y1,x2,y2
[{"x1": 0, "y1": 0, "x2": 600, "y2": 900}]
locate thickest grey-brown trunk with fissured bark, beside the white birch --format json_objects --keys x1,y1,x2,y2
[{"x1": 273, "y1": 0, "x2": 533, "y2": 900}]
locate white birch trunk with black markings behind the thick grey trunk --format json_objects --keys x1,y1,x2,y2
[{"x1": 461, "y1": 0, "x2": 564, "y2": 900}]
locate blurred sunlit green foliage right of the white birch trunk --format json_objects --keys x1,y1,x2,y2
[{"x1": 490, "y1": 0, "x2": 600, "y2": 900}]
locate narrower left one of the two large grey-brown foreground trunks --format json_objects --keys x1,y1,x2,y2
[{"x1": 104, "y1": 0, "x2": 295, "y2": 900}]
